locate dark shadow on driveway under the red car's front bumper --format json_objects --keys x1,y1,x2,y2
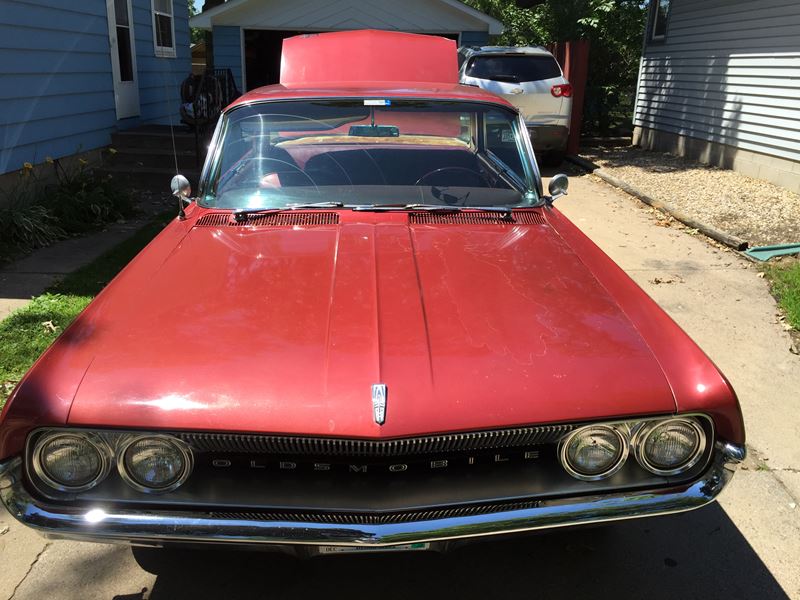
[{"x1": 125, "y1": 504, "x2": 787, "y2": 600}]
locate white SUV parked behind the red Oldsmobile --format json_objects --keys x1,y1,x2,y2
[{"x1": 458, "y1": 46, "x2": 572, "y2": 164}]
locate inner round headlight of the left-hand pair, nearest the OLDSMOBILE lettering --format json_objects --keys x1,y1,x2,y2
[{"x1": 117, "y1": 436, "x2": 192, "y2": 493}]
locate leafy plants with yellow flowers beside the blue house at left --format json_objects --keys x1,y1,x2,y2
[{"x1": 0, "y1": 154, "x2": 134, "y2": 261}]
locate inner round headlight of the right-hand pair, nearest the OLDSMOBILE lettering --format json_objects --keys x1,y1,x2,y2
[{"x1": 560, "y1": 425, "x2": 628, "y2": 481}]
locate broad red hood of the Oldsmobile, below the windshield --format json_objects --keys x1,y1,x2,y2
[{"x1": 66, "y1": 213, "x2": 675, "y2": 437}]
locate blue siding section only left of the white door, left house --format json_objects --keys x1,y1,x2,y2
[{"x1": 0, "y1": 0, "x2": 116, "y2": 173}]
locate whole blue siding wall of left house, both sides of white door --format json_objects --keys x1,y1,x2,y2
[{"x1": 0, "y1": 0, "x2": 191, "y2": 174}]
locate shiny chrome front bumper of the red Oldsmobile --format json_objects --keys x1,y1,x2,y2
[{"x1": 0, "y1": 444, "x2": 746, "y2": 549}]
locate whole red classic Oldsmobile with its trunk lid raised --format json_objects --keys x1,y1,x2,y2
[{"x1": 0, "y1": 31, "x2": 745, "y2": 555}]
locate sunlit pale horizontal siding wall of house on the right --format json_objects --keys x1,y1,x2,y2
[{"x1": 634, "y1": 0, "x2": 800, "y2": 187}]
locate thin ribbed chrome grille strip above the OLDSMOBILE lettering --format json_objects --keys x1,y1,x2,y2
[{"x1": 176, "y1": 425, "x2": 574, "y2": 458}]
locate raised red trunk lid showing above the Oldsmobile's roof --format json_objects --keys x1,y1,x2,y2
[{"x1": 280, "y1": 29, "x2": 458, "y2": 87}]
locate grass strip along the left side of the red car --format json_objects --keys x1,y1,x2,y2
[{"x1": 0, "y1": 211, "x2": 174, "y2": 408}]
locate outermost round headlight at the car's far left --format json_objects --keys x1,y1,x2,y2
[{"x1": 33, "y1": 433, "x2": 109, "y2": 492}]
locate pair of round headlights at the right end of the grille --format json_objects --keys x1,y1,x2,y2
[{"x1": 559, "y1": 417, "x2": 706, "y2": 481}]
